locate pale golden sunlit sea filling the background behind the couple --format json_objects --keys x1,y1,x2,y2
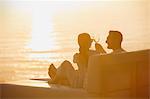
[{"x1": 0, "y1": 0, "x2": 150, "y2": 82}]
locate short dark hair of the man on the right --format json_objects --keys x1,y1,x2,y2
[{"x1": 109, "y1": 30, "x2": 123, "y2": 43}]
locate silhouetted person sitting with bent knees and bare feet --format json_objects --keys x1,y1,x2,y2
[{"x1": 48, "y1": 33, "x2": 106, "y2": 87}]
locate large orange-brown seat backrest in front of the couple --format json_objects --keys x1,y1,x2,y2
[{"x1": 85, "y1": 50, "x2": 150, "y2": 97}]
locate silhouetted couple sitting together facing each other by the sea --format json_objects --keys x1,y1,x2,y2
[{"x1": 48, "y1": 30, "x2": 125, "y2": 88}]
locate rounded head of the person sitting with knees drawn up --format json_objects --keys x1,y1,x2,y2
[{"x1": 78, "y1": 33, "x2": 93, "y2": 49}]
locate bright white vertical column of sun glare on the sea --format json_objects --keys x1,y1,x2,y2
[{"x1": 28, "y1": 3, "x2": 55, "y2": 51}]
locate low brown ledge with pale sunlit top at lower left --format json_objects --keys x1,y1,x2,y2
[{"x1": 0, "y1": 80, "x2": 88, "y2": 99}]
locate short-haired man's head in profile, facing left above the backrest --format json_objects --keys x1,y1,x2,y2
[{"x1": 106, "y1": 30, "x2": 123, "y2": 50}]
